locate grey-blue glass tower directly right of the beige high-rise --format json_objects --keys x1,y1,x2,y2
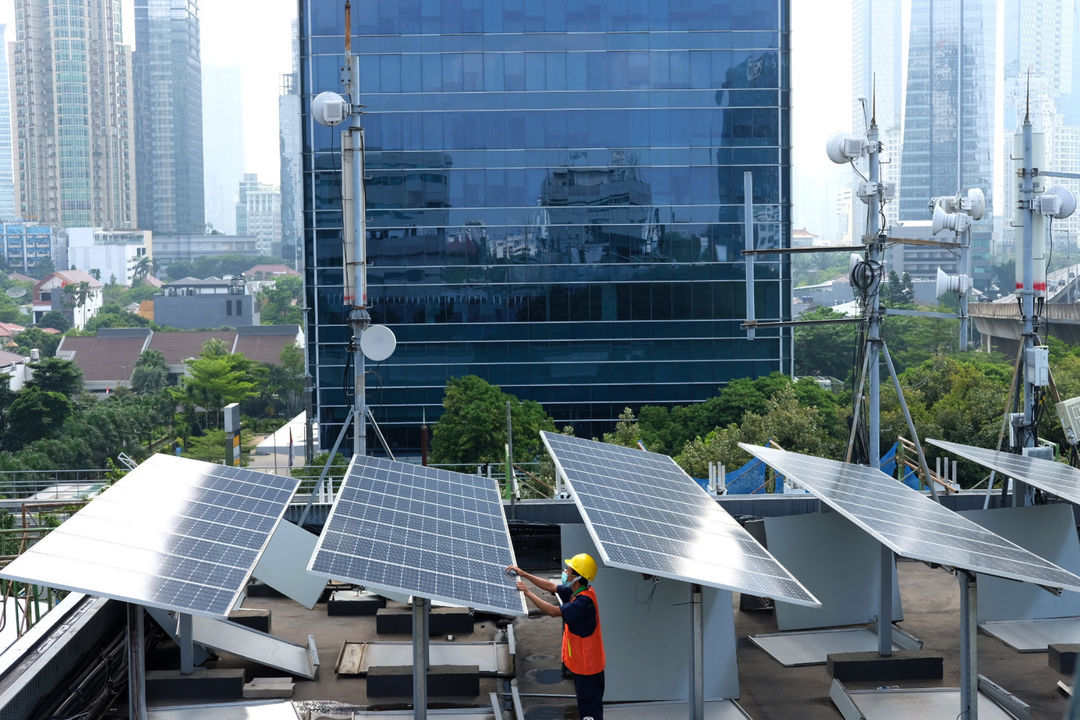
[{"x1": 133, "y1": 0, "x2": 205, "y2": 234}]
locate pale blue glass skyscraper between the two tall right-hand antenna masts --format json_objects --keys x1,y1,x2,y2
[{"x1": 899, "y1": 0, "x2": 997, "y2": 288}]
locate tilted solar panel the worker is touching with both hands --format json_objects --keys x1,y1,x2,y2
[{"x1": 308, "y1": 457, "x2": 526, "y2": 615}]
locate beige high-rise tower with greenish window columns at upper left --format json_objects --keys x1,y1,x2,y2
[{"x1": 12, "y1": 0, "x2": 137, "y2": 229}]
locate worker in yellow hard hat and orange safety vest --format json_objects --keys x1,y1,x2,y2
[{"x1": 507, "y1": 553, "x2": 605, "y2": 720}]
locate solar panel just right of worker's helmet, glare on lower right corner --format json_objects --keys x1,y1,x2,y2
[{"x1": 540, "y1": 432, "x2": 821, "y2": 607}]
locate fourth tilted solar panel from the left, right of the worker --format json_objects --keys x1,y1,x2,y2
[{"x1": 739, "y1": 443, "x2": 1080, "y2": 592}]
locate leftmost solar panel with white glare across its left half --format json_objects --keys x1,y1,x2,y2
[{"x1": 0, "y1": 454, "x2": 299, "y2": 617}]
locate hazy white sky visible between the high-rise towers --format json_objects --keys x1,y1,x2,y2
[{"x1": 0, "y1": 0, "x2": 852, "y2": 228}]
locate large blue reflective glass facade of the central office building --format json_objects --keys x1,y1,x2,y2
[{"x1": 300, "y1": 0, "x2": 791, "y2": 452}]
